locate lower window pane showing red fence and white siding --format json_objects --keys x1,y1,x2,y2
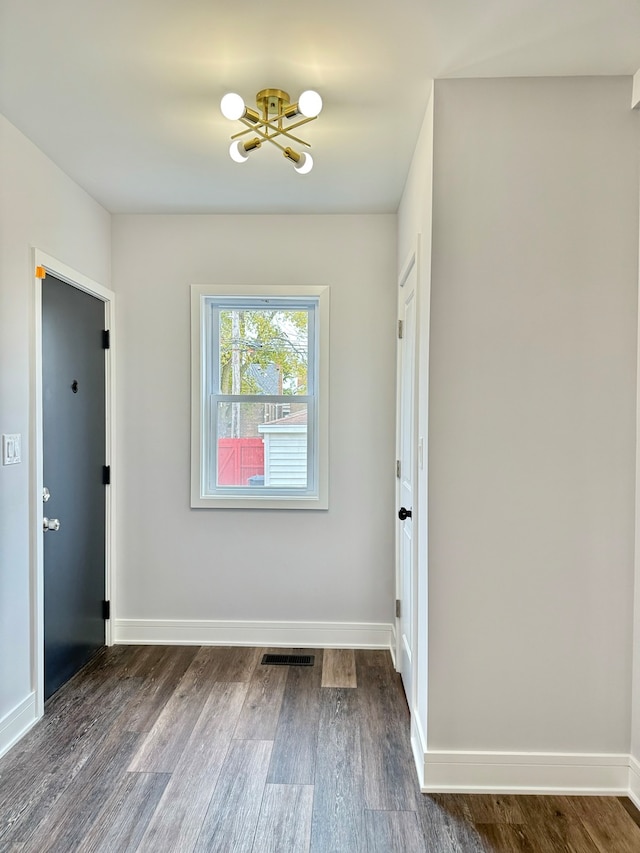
[{"x1": 217, "y1": 402, "x2": 307, "y2": 489}]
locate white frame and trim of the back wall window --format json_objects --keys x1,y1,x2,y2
[{"x1": 191, "y1": 284, "x2": 329, "y2": 510}]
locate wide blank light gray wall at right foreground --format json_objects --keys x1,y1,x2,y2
[{"x1": 428, "y1": 78, "x2": 640, "y2": 753}]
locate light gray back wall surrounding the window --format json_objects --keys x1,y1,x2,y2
[{"x1": 113, "y1": 215, "x2": 396, "y2": 636}]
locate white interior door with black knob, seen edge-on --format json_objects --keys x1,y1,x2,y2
[{"x1": 396, "y1": 258, "x2": 417, "y2": 708}]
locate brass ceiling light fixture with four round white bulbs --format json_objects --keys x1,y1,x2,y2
[{"x1": 220, "y1": 89, "x2": 322, "y2": 175}]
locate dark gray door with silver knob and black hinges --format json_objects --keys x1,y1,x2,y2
[{"x1": 42, "y1": 275, "x2": 105, "y2": 699}]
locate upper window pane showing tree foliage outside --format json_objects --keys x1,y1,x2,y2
[{"x1": 219, "y1": 308, "x2": 309, "y2": 396}]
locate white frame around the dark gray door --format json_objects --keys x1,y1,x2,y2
[{"x1": 29, "y1": 249, "x2": 116, "y2": 719}]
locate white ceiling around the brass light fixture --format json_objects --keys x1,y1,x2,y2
[{"x1": 0, "y1": 0, "x2": 640, "y2": 213}]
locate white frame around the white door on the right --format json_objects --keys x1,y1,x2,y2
[{"x1": 395, "y1": 245, "x2": 420, "y2": 717}]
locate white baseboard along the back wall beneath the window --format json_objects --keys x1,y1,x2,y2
[{"x1": 114, "y1": 619, "x2": 394, "y2": 649}]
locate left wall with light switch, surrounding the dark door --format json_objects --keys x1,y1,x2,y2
[{"x1": 0, "y1": 116, "x2": 110, "y2": 749}]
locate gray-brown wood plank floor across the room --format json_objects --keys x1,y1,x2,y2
[{"x1": 0, "y1": 646, "x2": 640, "y2": 853}]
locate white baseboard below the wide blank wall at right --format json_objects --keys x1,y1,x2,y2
[{"x1": 422, "y1": 751, "x2": 640, "y2": 796}]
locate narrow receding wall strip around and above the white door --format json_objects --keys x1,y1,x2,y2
[{"x1": 398, "y1": 86, "x2": 433, "y2": 751}]
